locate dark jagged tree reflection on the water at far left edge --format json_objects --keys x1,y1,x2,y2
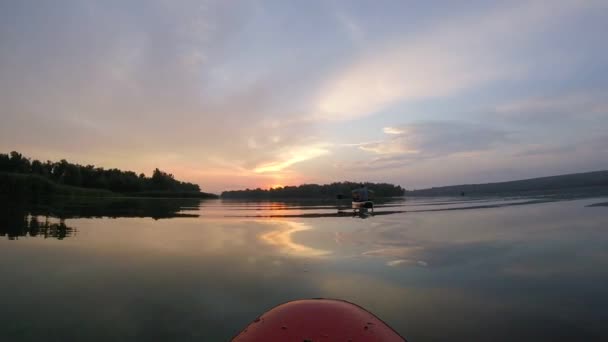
[{"x1": 0, "y1": 205, "x2": 76, "y2": 240}]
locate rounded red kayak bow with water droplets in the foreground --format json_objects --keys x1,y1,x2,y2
[{"x1": 233, "y1": 299, "x2": 405, "y2": 342}]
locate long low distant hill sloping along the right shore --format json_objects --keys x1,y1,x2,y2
[{"x1": 406, "y1": 171, "x2": 608, "y2": 196}]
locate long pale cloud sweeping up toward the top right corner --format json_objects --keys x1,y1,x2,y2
[{"x1": 316, "y1": 1, "x2": 597, "y2": 120}]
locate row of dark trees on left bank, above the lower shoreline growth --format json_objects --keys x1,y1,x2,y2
[{"x1": 0, "y1": 151, "x2": 201, "y2": 194}]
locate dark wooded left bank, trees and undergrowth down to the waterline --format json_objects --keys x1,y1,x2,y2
[{"x1": 0, "y1": 151, "x2": 212, "y2": 197}]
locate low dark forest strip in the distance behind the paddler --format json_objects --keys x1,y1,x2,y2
[{"x1": 222, "y1": 182, "x2": 405, "y2": 199}]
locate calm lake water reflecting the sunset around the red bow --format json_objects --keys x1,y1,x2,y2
[{"x1": 0, "y1": 197, "x2": 608, "y2": 342}]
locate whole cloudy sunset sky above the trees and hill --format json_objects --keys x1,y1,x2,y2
[{"x1": 0, "y1": 0, "x2": 608, "y2": 192}]
